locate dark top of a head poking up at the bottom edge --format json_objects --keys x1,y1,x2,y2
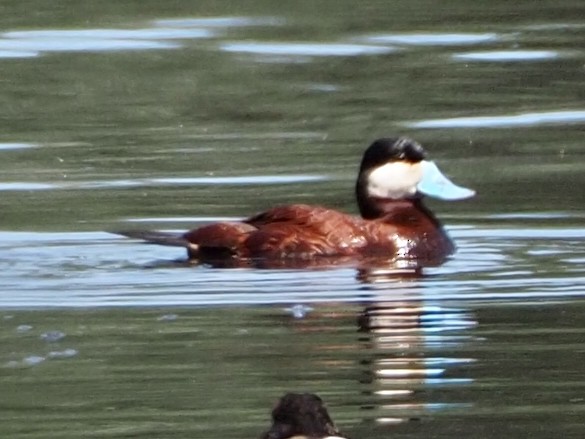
[{"x1": 261, "y1": 393, "x2": 345, "y2": 439}]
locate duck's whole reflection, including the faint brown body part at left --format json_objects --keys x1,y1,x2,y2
[{"x1": 279, "y1": 286, "x2": 481, "y2": 428}]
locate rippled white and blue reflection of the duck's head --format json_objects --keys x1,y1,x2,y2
[{"x1": 358, "y1": 287, "x2": 478, "y2": 424}]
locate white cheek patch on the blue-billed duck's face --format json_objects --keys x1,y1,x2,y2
[{"x1": 368, "y1": 161, "x2": 422, "y2": 200}]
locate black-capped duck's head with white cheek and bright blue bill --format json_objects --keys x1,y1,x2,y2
[{"x1": 356, "y1": 137, "x2": 475, "y2": 219}]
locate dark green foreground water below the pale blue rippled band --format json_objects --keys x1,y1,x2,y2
[{"x1": 0, "y1": 305, "x2": 585, "y2": 438}]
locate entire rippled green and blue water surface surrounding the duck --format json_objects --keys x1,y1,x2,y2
[{"x1": 0, "y1": 0, "x2": 585, "y2": 439}]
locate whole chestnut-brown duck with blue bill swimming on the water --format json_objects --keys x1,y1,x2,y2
[{"x1": 114, "y1": 137, "x2": 475, "y2": 267}]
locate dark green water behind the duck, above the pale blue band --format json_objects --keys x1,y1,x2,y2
[{"x1": 0, "y1": 2, "x2": 583, "y2": 230}]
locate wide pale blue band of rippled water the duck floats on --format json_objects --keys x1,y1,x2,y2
[{"x1": 0, "y1": 223, "x2": 585, "y2": 310}]
